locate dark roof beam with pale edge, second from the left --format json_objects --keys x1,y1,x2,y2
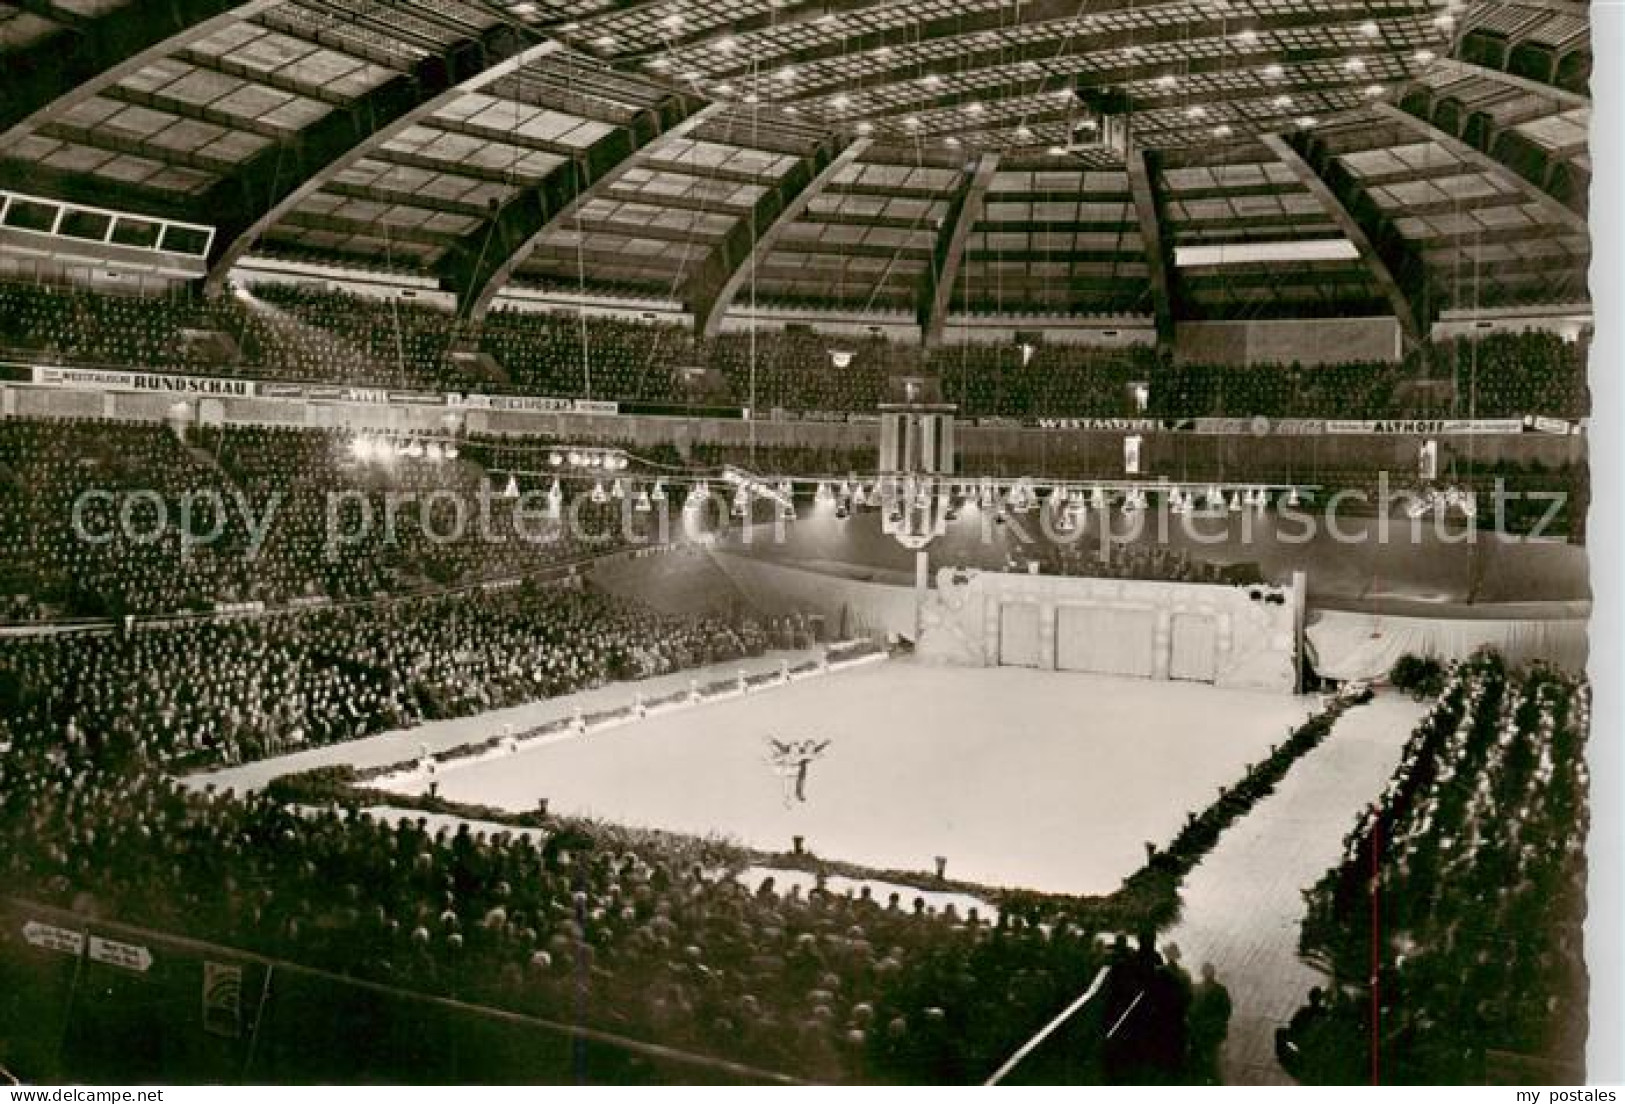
[{"x1": 202, "y1": 36, "x2": 564, "y2": 293}]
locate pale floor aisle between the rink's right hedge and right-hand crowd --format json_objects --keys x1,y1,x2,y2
[{"x1": 1164, "y1": 693, "x2": 1424, "y2": 1084}]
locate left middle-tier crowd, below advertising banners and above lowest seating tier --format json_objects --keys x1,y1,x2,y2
[{"x1": 0, "y1": 418, "x2": 658, "y2": 621}]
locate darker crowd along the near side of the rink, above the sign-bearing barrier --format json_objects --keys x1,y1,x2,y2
[{"x1": 0, "y1": 756, "x2": 1131, "y2": 1083}]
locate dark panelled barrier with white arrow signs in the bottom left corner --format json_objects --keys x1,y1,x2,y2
[{"x1": 0, "y1": 898, "x2": 795, "y2": 1084}]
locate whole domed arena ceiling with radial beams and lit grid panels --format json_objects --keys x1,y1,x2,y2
[{"x1": 0, "y1": 0, "x2": 1591, "y2": 343}]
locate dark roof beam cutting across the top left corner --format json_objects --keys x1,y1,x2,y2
[{"x1": 0, "y1": 0, "x2": 280, "y2": 148}]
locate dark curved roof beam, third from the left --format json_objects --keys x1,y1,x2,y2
[{"x1": 444, "y1": 96, "x2": 726, "y2": 322}]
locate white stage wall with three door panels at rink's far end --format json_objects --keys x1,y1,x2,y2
[{"x1": 920, "y1": 567, "x2": 1303, "y2": 691}]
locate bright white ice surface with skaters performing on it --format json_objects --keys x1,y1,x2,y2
[{"x1": 383, "y1": 660, "x2": 1311, "y2": 893}]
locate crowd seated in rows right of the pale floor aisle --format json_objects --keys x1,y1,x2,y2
[{"x1": 1277, "y1": 654, "x2": 1591, "y2": 1084}]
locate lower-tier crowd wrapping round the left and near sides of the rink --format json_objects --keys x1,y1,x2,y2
[{"x1": 0, "y1": 569, "x2": 1211, "y2": 1083}]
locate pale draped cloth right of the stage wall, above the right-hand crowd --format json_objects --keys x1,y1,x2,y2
[{"x1": 1307, "y1": 610, "x2": 1588, "y2": 680}]
